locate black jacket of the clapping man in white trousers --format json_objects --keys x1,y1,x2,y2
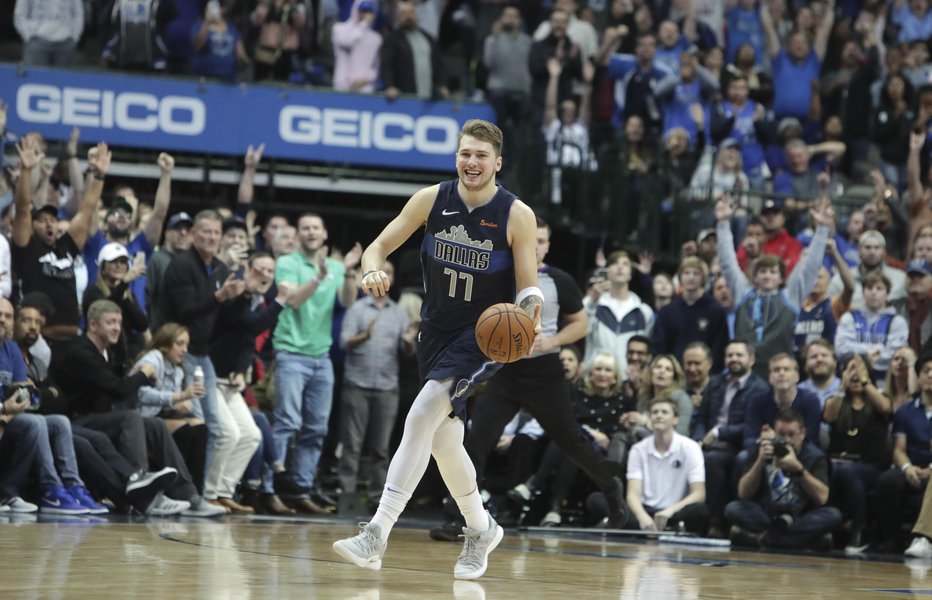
[{"x1": 210, "y1": 294, "x2": 284, "y2": 377}]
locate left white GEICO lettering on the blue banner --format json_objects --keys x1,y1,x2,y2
[{"x1": 16, "y1": 83, "x2": 207, "y2": 135}]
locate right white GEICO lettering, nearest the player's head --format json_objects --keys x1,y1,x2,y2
[{"x1": 278, "y1": 106, "x2": 460, "y2": 154}]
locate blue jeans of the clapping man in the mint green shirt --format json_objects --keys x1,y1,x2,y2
[{"x1": 272, "y1": 350, "x2": 333, "y2": 488}]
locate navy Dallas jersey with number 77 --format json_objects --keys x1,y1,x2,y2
[{"x1": 421, "y1": 179, "x2": 515, "y2": 331}]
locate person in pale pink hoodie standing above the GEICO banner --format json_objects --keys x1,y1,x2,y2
[{"x1": 330, "y1": 0, "x2": 382, "y2": 94}]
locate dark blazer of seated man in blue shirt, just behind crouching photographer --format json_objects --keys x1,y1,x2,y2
[{"x1": 692, "y1": 373, "x2": 770, "y2": 452}]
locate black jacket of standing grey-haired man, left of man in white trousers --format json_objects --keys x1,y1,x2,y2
[{"x1": 161, "y1": 246, "x2": 230, "y2": 356}]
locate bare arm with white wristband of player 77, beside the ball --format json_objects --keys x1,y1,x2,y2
[{"x1": 508, "y1": 200, "x2": 544, "y2": 333}]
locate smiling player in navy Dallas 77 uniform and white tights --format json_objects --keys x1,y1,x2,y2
[{"x1": 333, "y1": 119, "x2": 544, "y2": 579}]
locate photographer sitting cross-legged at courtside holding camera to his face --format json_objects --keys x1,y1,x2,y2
[{"x1": 725, "y1": 409, "x2": 841, "y2": 551}]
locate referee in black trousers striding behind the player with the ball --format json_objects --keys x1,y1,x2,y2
[{"x1": 431, "y1": 219, "x2": 628, "y2": 539}]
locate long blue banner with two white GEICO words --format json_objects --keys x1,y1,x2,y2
[{"x1": 0, "y1": 65, "x2": 494, "y2": 171}]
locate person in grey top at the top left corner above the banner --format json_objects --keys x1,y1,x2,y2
[{"x1": 13, "y1": 0, "x2": 84, "y2": 67}]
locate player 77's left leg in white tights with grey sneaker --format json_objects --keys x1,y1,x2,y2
[{"x1": 333, "y1": 379, "x2": 462, "y2": 570}]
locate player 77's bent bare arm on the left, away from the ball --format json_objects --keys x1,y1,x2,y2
[{"x1": 360, "y1": 184, "x2": 440, "y2": 296}]
